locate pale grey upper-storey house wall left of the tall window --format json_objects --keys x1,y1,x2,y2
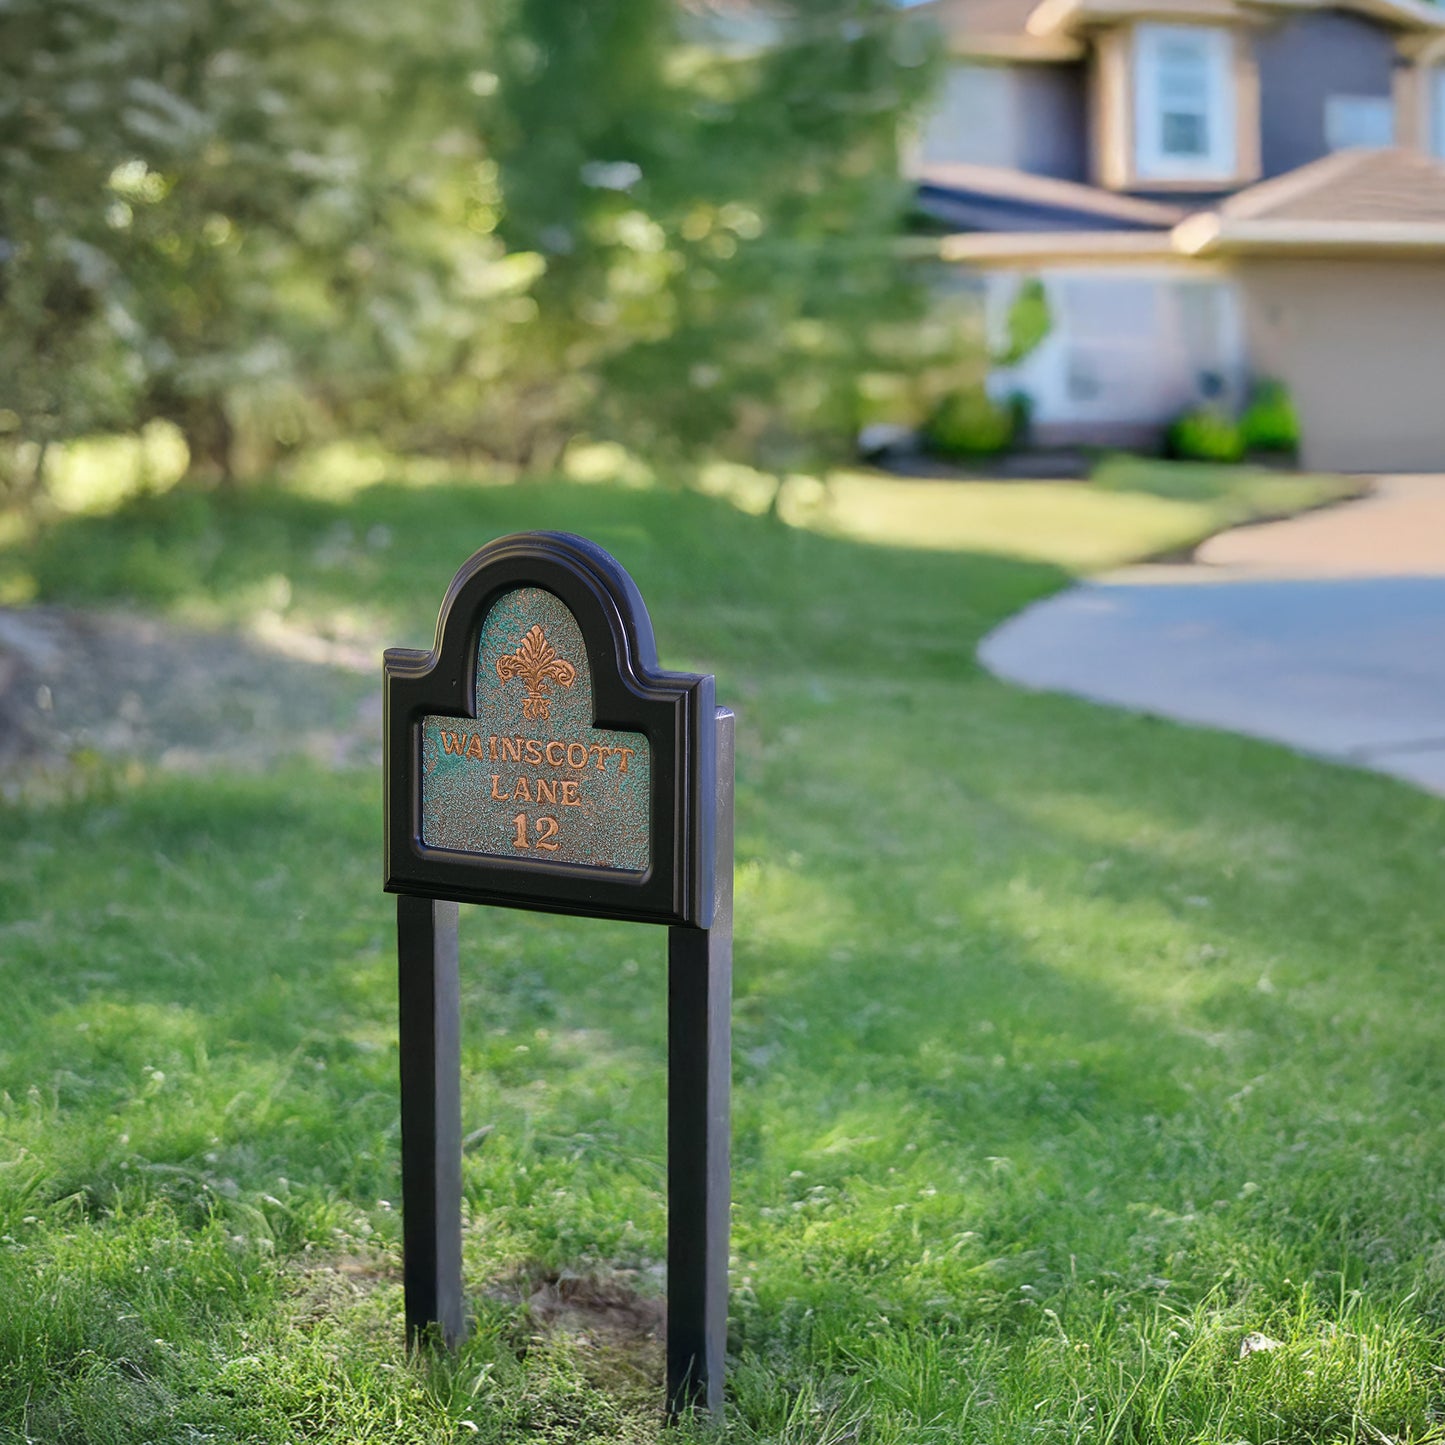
[{"x1": 919, "y1": 64, "x2": 1088, "y2": 181}]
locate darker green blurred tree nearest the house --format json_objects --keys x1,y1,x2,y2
[{"x1": 486, "y1": 0, "x2": 932, "y2": 471}]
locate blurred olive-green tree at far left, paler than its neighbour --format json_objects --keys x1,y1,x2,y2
[{"x1": 0, "y1": 0, "x2": 497, "y2": 487}]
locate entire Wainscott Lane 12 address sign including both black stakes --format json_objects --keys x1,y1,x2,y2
[{"x1": 383, "y1": 532, "x2": 733, "y2": 1413}]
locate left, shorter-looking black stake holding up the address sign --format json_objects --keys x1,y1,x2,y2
[{"x1": 396, "y1": 893, "x2": 465, "y2": 1348}]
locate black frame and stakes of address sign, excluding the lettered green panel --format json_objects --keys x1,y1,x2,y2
[{"x1": 383, "y1": 532, "x2": 734, "y2": 1418}]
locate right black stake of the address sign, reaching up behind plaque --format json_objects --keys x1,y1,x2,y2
[{"x1": 666, "y1": 708, "x2": 733, "y2": 1418}]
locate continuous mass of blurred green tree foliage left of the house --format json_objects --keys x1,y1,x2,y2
[{"x1": 0, "y1": 0, "x2": 929, "y2": 487}]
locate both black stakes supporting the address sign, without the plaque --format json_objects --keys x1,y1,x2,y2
[{"x1": 396, "y1": 708, "x2": 733, "y2": 1416}]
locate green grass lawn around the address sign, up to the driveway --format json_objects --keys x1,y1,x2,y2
[{"x1": 0, "y1": 468, "x2": 1445, "y2": 1445}]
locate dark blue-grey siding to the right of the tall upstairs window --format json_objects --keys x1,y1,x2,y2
[{"x1": 1256, "y1": 10, "x2": 1399, "y2": 176}]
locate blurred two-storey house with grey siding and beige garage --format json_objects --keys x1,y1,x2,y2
[{"x1": 913, "y1": 0, "x2": 1445, "y2": 471}]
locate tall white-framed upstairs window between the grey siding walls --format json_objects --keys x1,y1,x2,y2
[{"x1": 1134, "y1": 25, "x2": 1238, "y2": 181}]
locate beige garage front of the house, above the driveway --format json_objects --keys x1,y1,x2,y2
[{"x1": 1237, "y1": 257, "x2": 1445, "y2": 471}]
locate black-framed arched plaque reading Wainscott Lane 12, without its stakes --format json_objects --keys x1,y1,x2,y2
[{"x1": 384, "y1": 532, "x2": 717, "y2": 928}]
